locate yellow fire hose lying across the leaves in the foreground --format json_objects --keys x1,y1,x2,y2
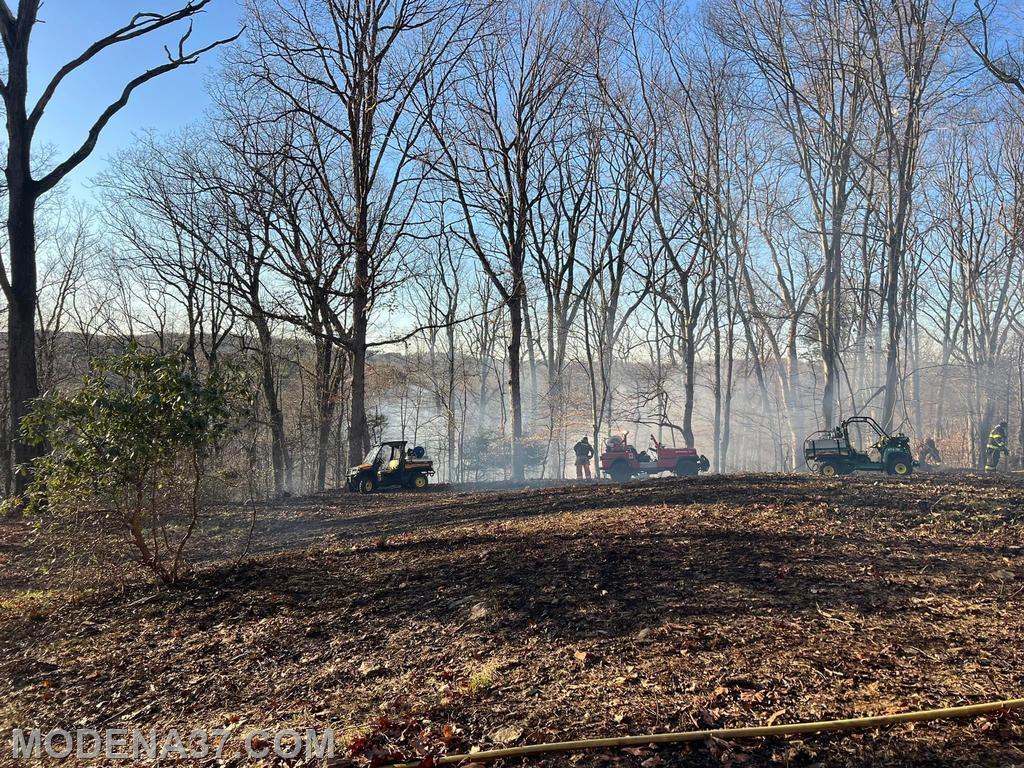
[{"x1": 391, "y1": 698, "x2": 1024, "y2": 768}]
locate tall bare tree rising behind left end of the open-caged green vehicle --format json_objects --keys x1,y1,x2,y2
[{"x1": 716, "y1": 0, "x2": 868, "y2": 424}]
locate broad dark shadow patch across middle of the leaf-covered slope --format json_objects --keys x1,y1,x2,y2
[{"x1": 193, "y1": 518, "x2": 1008, "y2": 642}]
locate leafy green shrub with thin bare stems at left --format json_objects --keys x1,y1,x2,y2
[{"x1": 22, "y1": 346, "x2": 241, "y2": 585}]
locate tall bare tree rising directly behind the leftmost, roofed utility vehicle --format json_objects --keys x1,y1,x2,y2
[{"x1": 246, "y1": 0, "x2": 473, "y2": 468}]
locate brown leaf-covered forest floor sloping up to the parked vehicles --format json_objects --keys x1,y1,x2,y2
[{"x1": 0, "y1": 475, "x2": 1024, "y2": 768}]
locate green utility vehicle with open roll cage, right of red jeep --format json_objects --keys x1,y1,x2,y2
[{"x1": 804, "y1": 416, "x2": 916, "y2": 477}]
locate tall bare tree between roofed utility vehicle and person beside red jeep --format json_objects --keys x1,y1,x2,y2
[{"x1": 430, "y1": 0, "x2": 581, "y2": 480}]
